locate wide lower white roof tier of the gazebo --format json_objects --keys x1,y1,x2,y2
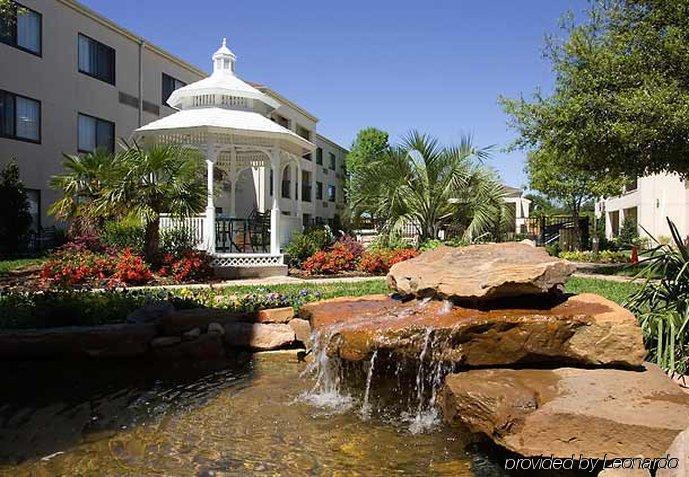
[{"x1": 136, "y1": 107, "x2": 315, "y2": 154}]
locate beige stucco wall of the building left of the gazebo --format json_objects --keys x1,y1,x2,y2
[{"x1": 0, "y1": 0, "x2": 203, "y2": 226}]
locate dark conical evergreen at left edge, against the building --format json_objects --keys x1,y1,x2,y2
[{"x1": 0, "y1": 161, "x2": 31, "y2": 256}]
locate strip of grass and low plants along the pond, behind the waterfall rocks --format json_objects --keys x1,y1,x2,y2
[{"x1": 0, "y1": 277, "x2": 638, "y2": 329}]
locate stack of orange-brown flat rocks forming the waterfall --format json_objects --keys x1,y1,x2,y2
[{"x1": 302, "y1": 243, "x2": 689, "y2": 459}]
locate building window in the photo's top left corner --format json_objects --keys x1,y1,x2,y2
[{"x1": 0, "y1": 2, "x2": 43, "y2": 56}]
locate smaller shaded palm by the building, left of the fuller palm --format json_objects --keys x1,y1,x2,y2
[{"x1": 48, "y1": 149, "x2": 114, "y2": 234}]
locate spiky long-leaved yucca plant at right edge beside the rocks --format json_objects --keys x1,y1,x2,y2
[{"x1": 626, "y1": 218, "x2": 689, "y2": 374}]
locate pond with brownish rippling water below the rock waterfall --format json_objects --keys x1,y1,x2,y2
[{"x1": 0, "y1": 352, "x2": 516, "y2": 476}]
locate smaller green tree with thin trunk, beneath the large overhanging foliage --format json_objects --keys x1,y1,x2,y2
[{"x1": 526, "y1": 148, "x2": 623, "y2": 246}]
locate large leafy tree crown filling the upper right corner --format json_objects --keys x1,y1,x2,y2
[{"x1": 501, "y1": 0, "x2": 689, "y2": 177}]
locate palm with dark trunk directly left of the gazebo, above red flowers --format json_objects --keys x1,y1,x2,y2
[{"x1": 94, "y1": 143, "x2": 207, "y2": 261}]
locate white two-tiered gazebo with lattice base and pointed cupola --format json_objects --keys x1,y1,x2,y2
[{"x1": 134, "y1": 40, "x2": 315, "y2": 276}]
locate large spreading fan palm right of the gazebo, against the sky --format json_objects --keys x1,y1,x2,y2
[{"x1": 351, "y1": 132, "x2": 506, "y2": 241}]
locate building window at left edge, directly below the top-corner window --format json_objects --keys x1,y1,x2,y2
[{"x1": 0, "y1": 91, "x2": 41, "y2": 142}]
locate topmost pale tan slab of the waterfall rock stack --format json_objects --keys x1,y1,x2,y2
[{"x1": 387, "y1": 242, "x2": 576, "y2": 301}]
